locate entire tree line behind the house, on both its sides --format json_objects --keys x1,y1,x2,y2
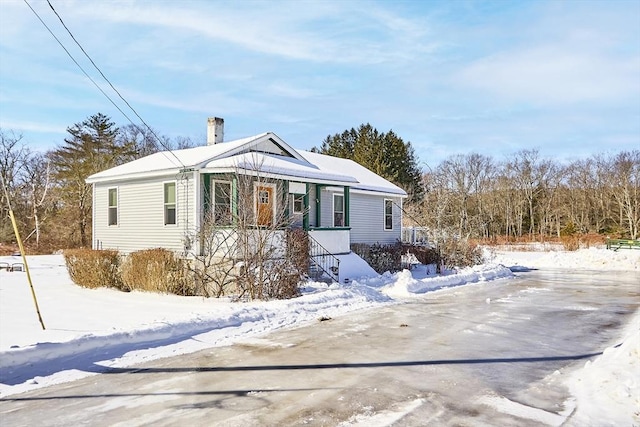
[{"x1": 0, "y1": 113, "x2": 640, "y2": 251}]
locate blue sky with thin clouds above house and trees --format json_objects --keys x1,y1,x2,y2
[{"x1": 0, "y1": 0, "x2": 640, "y2": 167}]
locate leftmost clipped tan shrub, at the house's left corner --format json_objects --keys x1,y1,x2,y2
[{"x1": 64, "y1": 249, "x2": 125, "y2": 290}]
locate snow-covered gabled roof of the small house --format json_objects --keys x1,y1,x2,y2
[{"x1": 87, "y1": 132, "x2": 407, "y2": 197}]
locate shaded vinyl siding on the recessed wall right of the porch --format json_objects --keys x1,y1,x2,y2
[{"x1": 349, "y1": 191, "x2": 402, "y2": 244}]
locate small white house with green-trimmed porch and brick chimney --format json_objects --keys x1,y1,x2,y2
[{"x1": 87, "y1": 118, "x2": 407, "y2": 278}]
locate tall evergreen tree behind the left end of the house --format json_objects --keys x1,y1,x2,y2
[{"x1": 49, "y1": 113, "x2": 135, "y2": 246}]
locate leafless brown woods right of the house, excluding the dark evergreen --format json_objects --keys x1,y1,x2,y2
[{"x1": 410, "y1": 150, "x2": 640, "y2": 239}]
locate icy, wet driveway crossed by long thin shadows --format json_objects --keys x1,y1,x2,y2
[{"x1": 0, "y1": 271, "x2": 640, "y2": 426}]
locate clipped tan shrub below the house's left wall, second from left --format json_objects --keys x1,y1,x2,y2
[{"x1": 122, "y1": 248, "x2": 194, "y2": 295}]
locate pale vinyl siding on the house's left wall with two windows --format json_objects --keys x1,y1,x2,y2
[{"x1": 93, "y1": 176, "x2": 196, "y2": 253}]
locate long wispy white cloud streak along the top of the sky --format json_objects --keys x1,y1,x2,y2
[{"x1": 65, "y1": 1, "x2": 436, "y2": 64}]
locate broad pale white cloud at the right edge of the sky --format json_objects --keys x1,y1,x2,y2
[{"x1": 453, "y1": 45, "x2": 640, "y2": 104}]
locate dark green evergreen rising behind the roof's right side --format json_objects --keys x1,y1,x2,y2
[{"x1": 312, "y1": 123, "x2": 424, "y2": 202}]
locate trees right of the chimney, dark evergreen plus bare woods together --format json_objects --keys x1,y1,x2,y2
[{"x1": 315, "y1": 124, "x2": 640, "y2": 239}]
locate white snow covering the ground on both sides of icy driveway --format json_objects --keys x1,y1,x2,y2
[{"x1": 0, "y1": 248, "x2": 640, "y2": 425}]
